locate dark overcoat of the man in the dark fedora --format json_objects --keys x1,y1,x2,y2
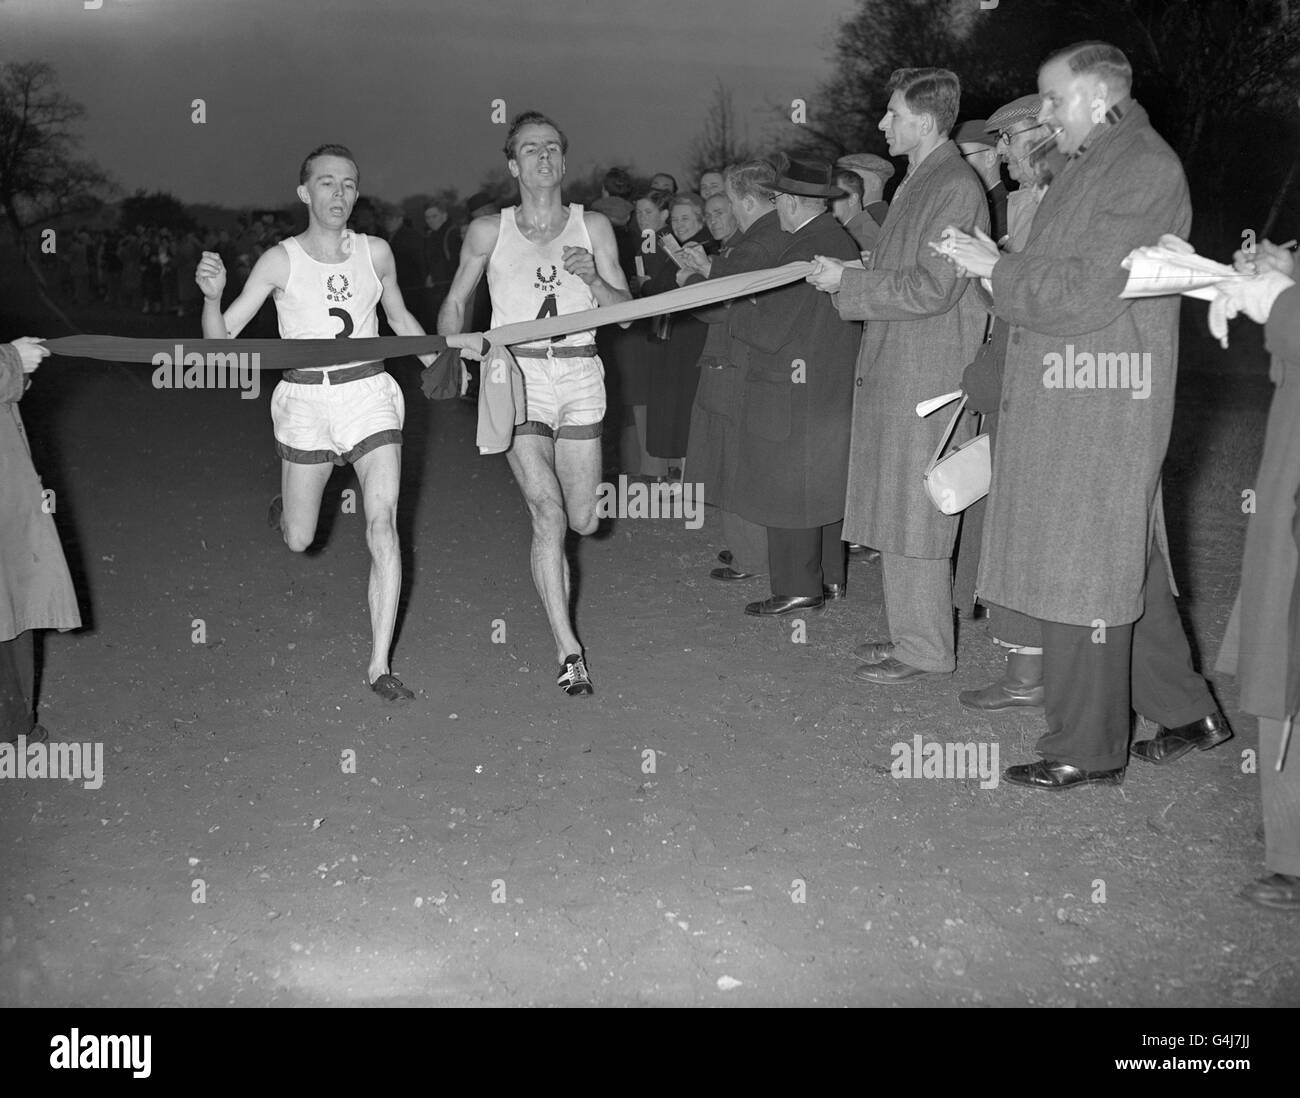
[{"x1": 729, "y1": 213, "x2": 862, "y2": 529}]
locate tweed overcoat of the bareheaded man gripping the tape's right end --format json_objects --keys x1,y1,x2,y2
[{"x1": 835, "y1": 142, "x2": 988, "y2": 560}]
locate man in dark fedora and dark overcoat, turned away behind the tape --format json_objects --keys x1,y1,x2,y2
[{"x1": 729, "y1": 156, "x2": 862, "y2": 615}]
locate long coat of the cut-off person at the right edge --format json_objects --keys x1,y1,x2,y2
[{"x1": 1217, "y1": 286, "x2": 1300, "y2": 722}]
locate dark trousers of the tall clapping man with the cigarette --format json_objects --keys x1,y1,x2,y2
[{"x1": 1036, "y1": 544, "x2": 1216, "y2": 771}]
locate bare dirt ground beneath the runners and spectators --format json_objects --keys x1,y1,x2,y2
[{"x1": 0, "y1": 300, "x2": 1300, "y2": 1006}]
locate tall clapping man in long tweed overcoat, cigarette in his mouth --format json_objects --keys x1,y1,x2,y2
[{"x1": 953, "y1": 42, "x2": 1231, "y2": 790}]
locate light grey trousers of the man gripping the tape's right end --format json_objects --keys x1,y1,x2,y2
[{"x1": 880, "y1": 552, "x2": 957, "y2": 672}]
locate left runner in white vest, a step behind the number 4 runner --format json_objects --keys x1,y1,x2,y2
[{"x1": 195, "y1": 144, "x2": 475, "y2": 702}]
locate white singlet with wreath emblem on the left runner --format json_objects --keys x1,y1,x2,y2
[{"x1": 276, "y1": 233, "x2": 384, "y2": 370}]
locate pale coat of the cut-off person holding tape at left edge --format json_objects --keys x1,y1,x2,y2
[{"x1": 0, "y1": 344, "x2": 81, "y2": 641}]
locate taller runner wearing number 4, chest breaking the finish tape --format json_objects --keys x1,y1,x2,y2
[{"x1": 438, "y1": 110, "x2": 632, "y2": 695}]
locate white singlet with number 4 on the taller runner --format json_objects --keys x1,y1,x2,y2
[{"x1": 488, "y1": 203, "x2": 599, "y2": 347}]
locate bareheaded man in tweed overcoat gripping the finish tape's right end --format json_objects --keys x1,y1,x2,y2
[{"x1": 809, "y1": 69, "x2": 988, "y2": 686}]
